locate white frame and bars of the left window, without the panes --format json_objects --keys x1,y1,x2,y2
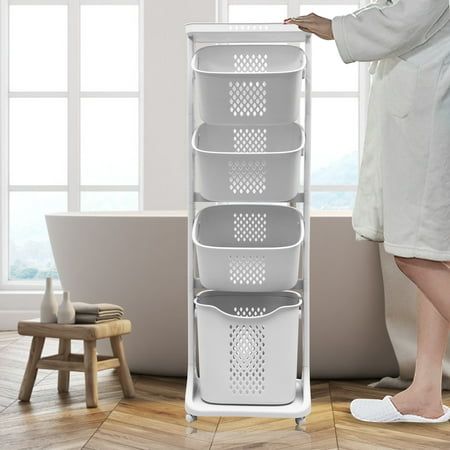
[{"x1": 0, "y1": 0, "x2": 144, "y2": 291}]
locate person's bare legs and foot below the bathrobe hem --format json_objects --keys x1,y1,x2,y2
[{"x1": 393, "y1": 257, "x2": 450, "y2": 418}]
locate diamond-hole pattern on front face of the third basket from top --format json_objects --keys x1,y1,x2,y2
[{"x1": 228, "y1": 256, "x2": 266, "y2": 285}]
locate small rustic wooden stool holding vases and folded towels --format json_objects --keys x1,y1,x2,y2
[{"x1": 17, "y1": 320, "x2": 134, "y2": 408}]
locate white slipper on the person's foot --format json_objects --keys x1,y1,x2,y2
[{"x1": 350, "y1": 395, "x2": 450, "y2": 423}]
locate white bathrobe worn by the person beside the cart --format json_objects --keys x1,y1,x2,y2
[{"x1": 332, "y1": 0, "x2": 450, "y2": 261}]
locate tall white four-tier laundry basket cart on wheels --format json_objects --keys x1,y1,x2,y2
[{"x1": 185, "y1": 23, "x2": 311, "y2": 424}]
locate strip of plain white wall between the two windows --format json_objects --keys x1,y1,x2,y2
[{"x1": 144, "y1": 0, "x2": 215, "y2": 209}]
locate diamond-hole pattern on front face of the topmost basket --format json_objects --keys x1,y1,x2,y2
[{"x1": 228, "y1": 81, "x2": 267, "y2": 117}]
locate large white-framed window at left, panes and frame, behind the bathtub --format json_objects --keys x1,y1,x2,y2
[{"x1": 0, "y1": 0, "x2": 143, "y2": 288}]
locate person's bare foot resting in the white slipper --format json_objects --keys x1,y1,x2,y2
[{"x1": 391, "y1": 386, "x2": 444, "y2": 419}]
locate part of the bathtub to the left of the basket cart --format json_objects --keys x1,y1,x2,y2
[{"x1": 46, "y1": 211, "x2": 187, "y2": 375}]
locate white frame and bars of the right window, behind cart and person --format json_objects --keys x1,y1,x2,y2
[{"x1": 216, "y1": 0, "x2": 370, "y2": 209}]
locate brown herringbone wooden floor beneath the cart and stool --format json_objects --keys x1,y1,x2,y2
[{"x1": 0, "y1": 332, "x2": 450, "y2": 450}]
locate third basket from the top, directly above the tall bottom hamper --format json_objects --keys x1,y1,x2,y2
[{"x1": 192, "y1": 204, "x2": 304, "y2": 292}]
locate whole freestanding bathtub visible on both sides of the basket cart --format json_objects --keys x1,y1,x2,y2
[{"x1": 47, "y1": 211, "x2": 398, "y2": 378}]
